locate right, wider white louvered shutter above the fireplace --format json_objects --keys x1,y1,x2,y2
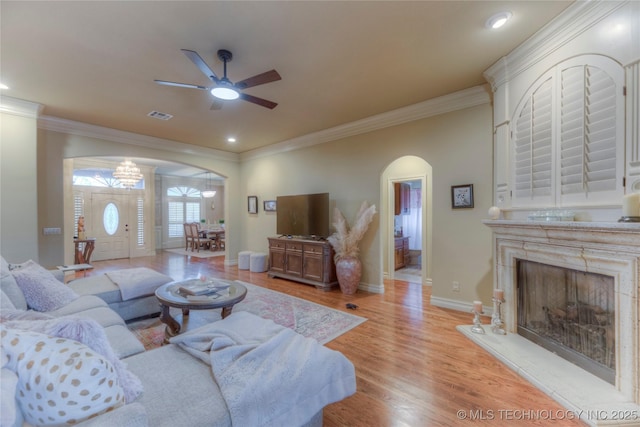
[{"x1": 559, "y1": 56, "x2": 624, "y2": 206}]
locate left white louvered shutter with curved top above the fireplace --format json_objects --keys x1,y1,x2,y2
[{"x1": 513, "y1": 78, "x2": 553, "y2": 206}]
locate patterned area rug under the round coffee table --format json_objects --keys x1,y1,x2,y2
[{"x1": 127, "y1": 281, "x2": 367, "y2": 350}]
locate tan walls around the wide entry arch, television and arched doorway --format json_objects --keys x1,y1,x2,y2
[{"x1": 3, "y1": 98, "x2": 492, "y2": 303}]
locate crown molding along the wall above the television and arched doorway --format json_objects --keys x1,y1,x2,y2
[{"x1": 240, "y1": 85, "x2": 491, "y2": 161}]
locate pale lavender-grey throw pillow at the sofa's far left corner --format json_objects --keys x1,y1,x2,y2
[{"x1": 11, "y1": 260, "x2": 78, "y2": 311}]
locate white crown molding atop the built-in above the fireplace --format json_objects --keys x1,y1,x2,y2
[{"x1": 483, "y1": 0, "x2": 629, "y2": 91}]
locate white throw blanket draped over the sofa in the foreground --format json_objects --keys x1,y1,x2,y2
[{"x1": 171, "y1": 311, "x2": 356, "y2": 426}]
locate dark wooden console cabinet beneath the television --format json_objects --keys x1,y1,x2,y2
[{"x1": 268, "y1": 237, "x2": 338, "y2": 290}]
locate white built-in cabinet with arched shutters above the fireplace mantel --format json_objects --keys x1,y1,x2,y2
[{"x1": 484, "y1": 1, "x2": 640, "y2": 214}]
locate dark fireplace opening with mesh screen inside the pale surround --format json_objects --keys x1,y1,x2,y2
[{"x1": 517, "y1": 259, "x2": 616, "y2": 385}]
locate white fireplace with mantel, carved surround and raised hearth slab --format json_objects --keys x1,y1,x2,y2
[{"x1": 458, "y1": 220, "x2": 640, "y2": 425}]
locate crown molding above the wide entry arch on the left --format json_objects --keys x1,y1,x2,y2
[{"x1": 38, "y1": 116, "x2": 239, "y2": 162}]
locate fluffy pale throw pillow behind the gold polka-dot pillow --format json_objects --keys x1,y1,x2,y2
[{"x1": 3, "y1": 316, "x2": 142, "y2": 403}]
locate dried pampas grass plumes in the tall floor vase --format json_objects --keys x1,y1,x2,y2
[{"x1": 327, "y1": 201, "x2": 376, "y2": 260}]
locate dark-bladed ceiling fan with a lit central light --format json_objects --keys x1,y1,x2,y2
[{"x1": 154, "y1": 49, "x2": 282, "y2": 110}]
